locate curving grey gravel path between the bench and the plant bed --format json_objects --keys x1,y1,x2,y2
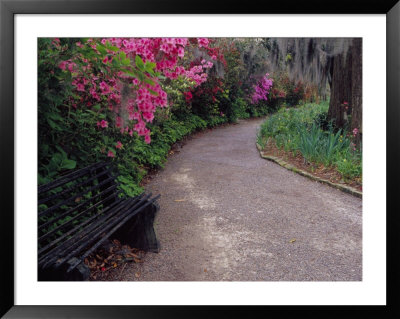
[{"x1": 110, "y1": 119, "x2": 362, "y2": 281}]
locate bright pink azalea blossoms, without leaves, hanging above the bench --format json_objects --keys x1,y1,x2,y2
[{"x1": 59, "y1": 38, "x2": 213, "y2": 143}]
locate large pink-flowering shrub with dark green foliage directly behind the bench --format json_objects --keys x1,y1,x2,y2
[{"x1": 38, "y1": 38, "x2": 216, "y2": 189}]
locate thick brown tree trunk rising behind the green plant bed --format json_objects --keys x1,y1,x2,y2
[{"x1": 328, "y1": 49, "x2": 352, "y2": 128}]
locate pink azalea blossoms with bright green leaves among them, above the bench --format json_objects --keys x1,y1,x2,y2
[{"x1": 59, "y1": 38, "x2": 213, "y2": 156}]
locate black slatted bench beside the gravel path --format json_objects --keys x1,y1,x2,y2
[{"x1": 38, "y1": 163, "x2": 160, "y2": 281}]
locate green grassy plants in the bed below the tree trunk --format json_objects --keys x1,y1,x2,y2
[{"x1": 257, "y1": 102, "x2": 362, "y2": 179}]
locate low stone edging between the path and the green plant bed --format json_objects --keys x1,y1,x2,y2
[{"x1": 256, "y1": 142, "x2": 362, "y2": 198}]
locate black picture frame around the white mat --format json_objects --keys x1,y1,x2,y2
[{"x1": 0, "y1": 0, "x2": 400, "y2": 318}]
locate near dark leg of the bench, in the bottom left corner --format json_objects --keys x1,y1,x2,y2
[{"x1": 38, "y1": 257, "x2": 90, "y2": 281}]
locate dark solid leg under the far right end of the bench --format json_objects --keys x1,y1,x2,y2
[{"x1": 113, "y1": 202, "x2": 160, "y2": 253}]
